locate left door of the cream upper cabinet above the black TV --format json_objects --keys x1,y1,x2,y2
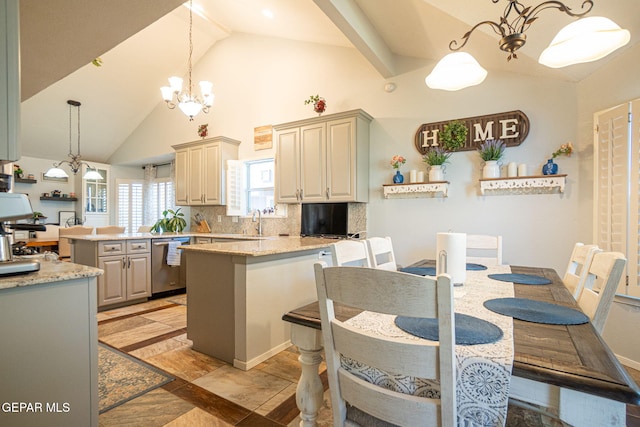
[{"x1": 274, "y1": 127, "x2": 300, "y2": 203}]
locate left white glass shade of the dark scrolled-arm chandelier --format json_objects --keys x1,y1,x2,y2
[{"x1": 425, "y1": 52, "x2": 487, "y2": 91}]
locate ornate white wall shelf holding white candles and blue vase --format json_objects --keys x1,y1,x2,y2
[{"x1": 480, "y1": 174, "x2": 567, "y2": 196}]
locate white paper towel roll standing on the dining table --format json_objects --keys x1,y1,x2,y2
[{"x1": 436, "y1": 233, "x2": 467, "y2": 286}]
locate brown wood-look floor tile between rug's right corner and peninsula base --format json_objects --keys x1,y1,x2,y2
[{"x1": 144, "y1": 343, "x2": 225, "y2": 381}]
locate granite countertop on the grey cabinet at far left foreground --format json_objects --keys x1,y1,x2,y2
[{"x1": 0, "y1": 257, "x2": 102, "y2": 290}]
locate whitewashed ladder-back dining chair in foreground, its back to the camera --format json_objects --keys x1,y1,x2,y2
[{"x1": 314, "y1": 262, "x2": 457, "y2": 426}]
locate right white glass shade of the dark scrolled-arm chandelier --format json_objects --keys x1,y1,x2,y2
[{"x1": 538, "y1": 16, "x2": 631, "y2": 68}]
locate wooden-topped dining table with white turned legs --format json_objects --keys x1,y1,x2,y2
[{"x1": 282, "y1": 260, "x2": 640, "y2": 427}]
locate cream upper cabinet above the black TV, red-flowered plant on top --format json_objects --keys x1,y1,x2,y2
[{"x1": 273, "y1": 110, "x2": 372, "y2": 203}]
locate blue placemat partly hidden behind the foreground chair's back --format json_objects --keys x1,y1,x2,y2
[{"x1": 395, "y1": 313, "x2": 502, "y2": 345}]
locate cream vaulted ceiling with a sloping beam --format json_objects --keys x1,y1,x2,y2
[{"x1": 20, "y1": 0, "x2": 640, "y2": 166}]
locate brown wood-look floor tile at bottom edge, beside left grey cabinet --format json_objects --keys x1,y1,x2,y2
[{"x1": 99, "y1": 388, "x2": 194, "y2": 427}]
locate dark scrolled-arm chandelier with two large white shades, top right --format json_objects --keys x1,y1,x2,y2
[{"x1": 425, "y1": 0, "x2": 630, "y2": 90}]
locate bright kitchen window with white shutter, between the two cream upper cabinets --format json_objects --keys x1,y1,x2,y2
[{"x1": 227, "y1": 159, "x2": 286, "y2": 217}]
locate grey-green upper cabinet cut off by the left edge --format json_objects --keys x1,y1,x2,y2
[{"x1": 0, "y1": 0, "x2": 20, "y2": 161}]
